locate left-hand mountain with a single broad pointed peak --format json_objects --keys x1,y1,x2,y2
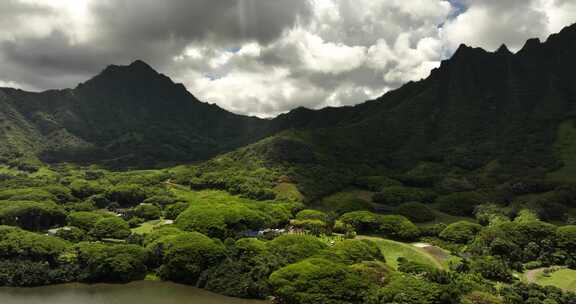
[{"x1": 0, "y1": 61, "x2": 267, "y2": 166}]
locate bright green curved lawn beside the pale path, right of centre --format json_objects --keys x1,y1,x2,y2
[{"x1": 358, "y1": 236, "x2": 448, "y2": 269}]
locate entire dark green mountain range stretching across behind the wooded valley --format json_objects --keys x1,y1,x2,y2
[{"x1": 0, "y1": 25, "x2": 576, "y2": 185}]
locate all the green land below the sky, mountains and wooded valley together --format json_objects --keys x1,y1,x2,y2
[{"x1": 0, "y1": 25, "x2": 576, "y2": 304}]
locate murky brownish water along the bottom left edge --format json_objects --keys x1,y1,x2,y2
[{"x1": 0, "y1": 281, "x2": 269, "y2": 304}]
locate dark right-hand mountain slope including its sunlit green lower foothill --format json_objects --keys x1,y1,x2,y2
[{"x1": 195, "y1": 25, "x2": 576, "y2": 197}]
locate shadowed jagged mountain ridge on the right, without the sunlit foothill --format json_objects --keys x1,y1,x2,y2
[{"x1": 266, "y1": 26, "x2": 576, "y2": 168}]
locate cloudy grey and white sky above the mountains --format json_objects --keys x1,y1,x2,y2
[{"x1": 0, "y1": 0, "x2": 576, "y2": 117}]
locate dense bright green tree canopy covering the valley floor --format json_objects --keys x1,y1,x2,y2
[{"x1": 0, "y1": 165, "x2": 576, "y2": 304}]
